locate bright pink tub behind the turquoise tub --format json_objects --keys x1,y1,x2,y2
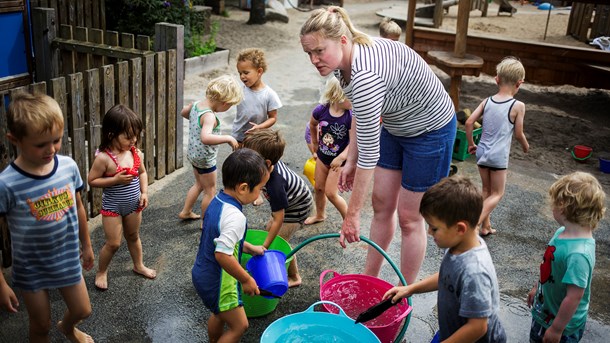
[{"x1": 320, "y1": 269, "x2": 412, "y2": 343}]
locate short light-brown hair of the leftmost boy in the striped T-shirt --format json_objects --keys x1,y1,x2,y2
[{"x1": 6, "y1": 92, "x2": 64, "y2": 139}]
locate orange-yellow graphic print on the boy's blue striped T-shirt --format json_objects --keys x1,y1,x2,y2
[{"x1": 27, "y1": 185, "x2": 74, "y2": 222}]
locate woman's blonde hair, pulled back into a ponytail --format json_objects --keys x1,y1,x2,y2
[{"x1": 301, "y1": 6, "x2": 373, "y2": 46}]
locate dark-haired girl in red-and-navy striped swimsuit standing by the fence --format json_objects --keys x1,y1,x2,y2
[{"x1": 88, "y1": 104, "x2": 157, "y2": 290}]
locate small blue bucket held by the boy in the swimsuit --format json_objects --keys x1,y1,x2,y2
[{"x1": 246, "y1": 250, "x2": 288, "y2": 299}]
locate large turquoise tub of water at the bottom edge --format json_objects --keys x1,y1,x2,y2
[{"x1": 261, "y1": 301, "x2": 379, "y2": 343}]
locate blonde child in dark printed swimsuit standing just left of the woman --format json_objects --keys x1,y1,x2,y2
[{"x1": 305, "y1": 76, "x2": 352, "y2": 225}]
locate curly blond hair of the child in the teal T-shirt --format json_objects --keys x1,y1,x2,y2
[{"x1": 549, "y1": 172, "x2": 606, "y2": 230}]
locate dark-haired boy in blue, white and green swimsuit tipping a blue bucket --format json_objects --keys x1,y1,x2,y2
[{"x1": 192, "y1": 149, "x2": 269, "y2": 342}]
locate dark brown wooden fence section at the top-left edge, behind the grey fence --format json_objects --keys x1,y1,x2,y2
[{"x1": 30, "y1": 0, "x2": 106, "y2": 30}]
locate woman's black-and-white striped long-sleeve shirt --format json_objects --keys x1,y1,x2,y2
[{"x1": 335, "y1": 38, "x2": 454, "y2": 169}]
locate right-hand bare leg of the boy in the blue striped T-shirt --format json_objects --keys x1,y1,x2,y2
[{"x1": 57, "y1": 278, "x2": 93, "y2": 343}]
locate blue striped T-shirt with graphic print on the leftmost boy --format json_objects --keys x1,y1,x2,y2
[{"x1": 0, "y1": 155, "x2": 84, "y2": 291}]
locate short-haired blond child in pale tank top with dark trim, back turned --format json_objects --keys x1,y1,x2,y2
[{"x1": 466, "y1": 56, "x2": 529, "y2": 237}]
